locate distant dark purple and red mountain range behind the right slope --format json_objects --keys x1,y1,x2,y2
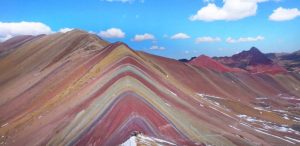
[{"x1": 179, "y1": 47, "x2": 300, "y2": 74}]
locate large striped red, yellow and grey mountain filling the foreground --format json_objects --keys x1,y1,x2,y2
[{"x1": 0, "y1": 30, "x2": 300, "y2": 146}]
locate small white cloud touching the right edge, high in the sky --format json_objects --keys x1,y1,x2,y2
[{"x1": 269, "y1": 7, "x2": 300, "y2": 21}]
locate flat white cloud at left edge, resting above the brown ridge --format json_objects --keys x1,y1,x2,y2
[{"x1": 0, "y1": 21, "x2": 52, "y2": 42}]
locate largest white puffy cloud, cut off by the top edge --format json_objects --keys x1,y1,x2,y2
[{"x1": 190, "y1": 0, "x2": 268, "y2": 21}]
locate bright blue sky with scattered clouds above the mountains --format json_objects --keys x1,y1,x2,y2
[{"x1": 0, "y1": 0, "x2": 300, "y2": 59}]
